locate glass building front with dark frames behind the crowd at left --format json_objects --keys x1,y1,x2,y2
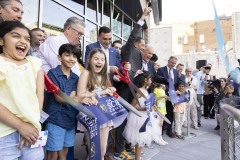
[{"x1": 21, "y1": 0, "x2": 147, "y2": 59}]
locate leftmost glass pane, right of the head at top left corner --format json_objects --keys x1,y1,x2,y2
[{"x1": 22, "y1": 0, "x2": 39, "y2": 29}]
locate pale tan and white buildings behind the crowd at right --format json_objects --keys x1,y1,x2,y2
[{"x1": 149, "y1": 13, "x2": 240, "y2": 77}]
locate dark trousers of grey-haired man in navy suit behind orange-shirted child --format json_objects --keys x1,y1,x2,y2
[{"x1": 163, "y1": 101, "x2": 173, "y2": 133}]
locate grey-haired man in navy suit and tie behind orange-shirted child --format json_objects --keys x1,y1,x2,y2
[{"x1": 157, "y1": 56, "x2": 180, "y2": 138}]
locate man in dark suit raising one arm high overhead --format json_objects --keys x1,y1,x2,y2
[{"x1": 114, "y1": 8, "x2": 151, "y2": 159}]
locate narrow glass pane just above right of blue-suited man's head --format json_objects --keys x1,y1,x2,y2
[{"x1": 112, "y1": 8, "x2": 122, "y2": 36}]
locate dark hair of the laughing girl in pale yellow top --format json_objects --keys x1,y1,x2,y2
[{"x1": 0, "y1": 21, "x2": 31, "y2": 54}]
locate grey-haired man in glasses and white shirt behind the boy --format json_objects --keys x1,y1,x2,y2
[{"x1": 37, "y1": 17, "x2": 85, "y2": 75}]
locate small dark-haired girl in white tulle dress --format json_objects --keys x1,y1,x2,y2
[{"x1": 123, "y1": 71, "x2": 156, "y2": 160}]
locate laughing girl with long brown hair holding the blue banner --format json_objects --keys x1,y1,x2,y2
[{"x1": 77, "y1": 49, "x2": 116, "y2": 160}]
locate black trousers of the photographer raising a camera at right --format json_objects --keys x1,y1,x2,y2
[{"x1": 203, "y1": 94, "x2": 215, "y2": 117}]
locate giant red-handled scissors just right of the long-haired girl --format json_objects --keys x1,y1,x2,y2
[{"x1": 117, "y1": 62, "x2": 147, "y2": 106}]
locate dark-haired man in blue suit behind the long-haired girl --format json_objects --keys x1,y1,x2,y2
[{"x1": 85, "y1": 26, "x2": 120, "y2": 73}]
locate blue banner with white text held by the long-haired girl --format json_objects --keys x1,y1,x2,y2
[{"x1": 77, "y1": 96, "x2": 128, "y2": 160}]
